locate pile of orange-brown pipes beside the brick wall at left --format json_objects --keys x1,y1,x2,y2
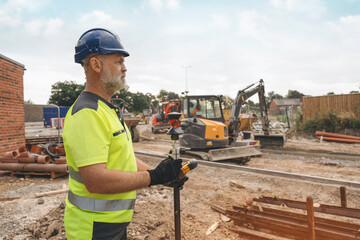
[{"x1": 0, "y1": 143, "x2": 68, "y2": 178}]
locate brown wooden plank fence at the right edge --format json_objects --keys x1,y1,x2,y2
[{"x1": 302, "y1": 94, "x2": 360, "y2": 122}]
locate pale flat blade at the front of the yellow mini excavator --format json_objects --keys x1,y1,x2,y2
[{"x1": 208, "y1": 146, "x2": 261, "y2": 161}]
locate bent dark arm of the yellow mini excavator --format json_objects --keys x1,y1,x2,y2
[{"x1": 228, "y1": 79, "x2": 269, "y2": 143}]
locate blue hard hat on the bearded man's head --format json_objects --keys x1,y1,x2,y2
[{"x1": 75, "y1": 28, "x2": 129, "y2": 63}]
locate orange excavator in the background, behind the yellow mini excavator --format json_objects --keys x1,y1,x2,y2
[{"x1": 151, "y1": 99, "x2": 181, "y2": 134}]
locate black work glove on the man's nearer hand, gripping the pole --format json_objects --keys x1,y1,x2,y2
[{"x1": 147, "y1": 156, "x2": 182, "y2": 186}]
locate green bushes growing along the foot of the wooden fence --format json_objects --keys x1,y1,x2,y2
[{"x1": 296, "y1": 112, "x2": 360, "y2": 133}]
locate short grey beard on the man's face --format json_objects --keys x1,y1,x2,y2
[{"x1": 100, "y1": 64, "x2": 126, "y2": 93}]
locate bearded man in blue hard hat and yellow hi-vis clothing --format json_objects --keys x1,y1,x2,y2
[{"x1": 63, "y1": 28, "x2": 181, "y2": 240}]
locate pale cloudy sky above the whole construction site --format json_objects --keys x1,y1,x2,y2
[{"x1": 0, "y1": 0, "x2": 360, "y2": 104}]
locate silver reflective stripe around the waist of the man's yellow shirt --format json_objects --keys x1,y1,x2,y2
[{"x1": 68, "y1": 190, "x2": 135, "y2": 212}]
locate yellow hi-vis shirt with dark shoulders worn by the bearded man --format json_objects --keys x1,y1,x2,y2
[{"x1": 63, "y1": 92, "x2": 137, "y2": 239}]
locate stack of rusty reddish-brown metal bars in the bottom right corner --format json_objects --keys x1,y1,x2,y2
[{"x1": 212, "y1": 188, "x2": 360, "y2": 240}]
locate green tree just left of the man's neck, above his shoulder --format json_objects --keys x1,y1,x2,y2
[{"x1": 48, "y1": 81, "x2": 85, "y2": 106}]
